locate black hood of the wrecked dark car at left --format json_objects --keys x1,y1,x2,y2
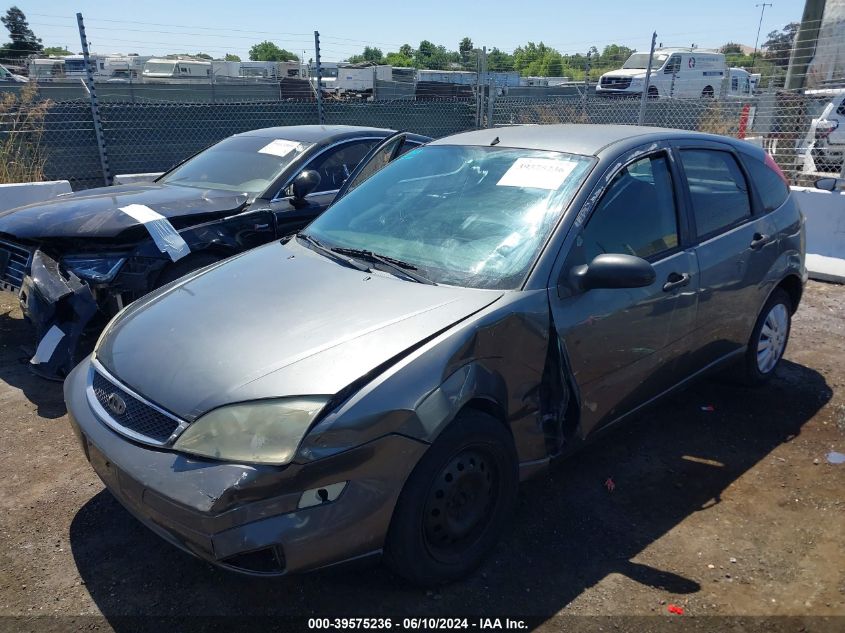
[{"x1": 0, "y1": 183, "x2": 247, "y2": 241}]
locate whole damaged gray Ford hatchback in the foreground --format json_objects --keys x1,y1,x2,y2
[{"x1": 65, "y1": 126, "x2": 806, "y2": 584}]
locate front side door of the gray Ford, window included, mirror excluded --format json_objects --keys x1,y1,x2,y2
[{"x1": 549, "y1": 147, "x2": 698, "y2": 436}]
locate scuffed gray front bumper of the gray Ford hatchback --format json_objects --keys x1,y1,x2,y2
[{"x1": 65, "y1": 360, "x2": 428, "y2": 575}]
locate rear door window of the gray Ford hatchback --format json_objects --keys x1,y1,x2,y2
[{"x1": 681, "y1": 149, "x2": 751, "y2": 236}]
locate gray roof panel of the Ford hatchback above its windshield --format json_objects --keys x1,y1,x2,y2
[{"x1": 430, "y1": 123, "x2": 752, "y2": 156}]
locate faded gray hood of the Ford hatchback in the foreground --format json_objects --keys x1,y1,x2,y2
[{"x1": 95, "y1": 242, "x2": 502, "y2": 420}]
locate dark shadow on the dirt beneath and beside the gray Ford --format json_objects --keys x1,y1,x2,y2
[{"x1": 70, "y1": 362, "x2": 832, "y2": 630}]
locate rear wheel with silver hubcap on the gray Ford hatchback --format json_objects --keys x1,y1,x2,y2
[{"x1": 741, "y1": 288, "x2": 792, "y2": 387}]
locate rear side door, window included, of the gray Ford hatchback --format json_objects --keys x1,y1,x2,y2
[{"x1": 676, "y1": 141, "x2": 779, "y2": 368}]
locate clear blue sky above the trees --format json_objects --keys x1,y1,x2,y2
[{"x1": 14, "y1": 0, "x2": 804, "y2": 61}]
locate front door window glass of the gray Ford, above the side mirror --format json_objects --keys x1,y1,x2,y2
[{"x1": 572, "y1": 155, "x2": 678, "y2": 265}]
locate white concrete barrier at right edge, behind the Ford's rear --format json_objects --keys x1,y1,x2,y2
[{"x1": 792, "y1": 187, "x2": 845, "y2": 283}]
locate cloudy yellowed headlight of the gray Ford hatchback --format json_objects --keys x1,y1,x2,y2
[{"x1": 173, "y1": 396, "x2": 329, "y2": 465}]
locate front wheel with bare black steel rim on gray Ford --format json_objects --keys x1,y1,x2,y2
[{"x1": 384, "y1": 410, "x2": 519, "y2": 587}]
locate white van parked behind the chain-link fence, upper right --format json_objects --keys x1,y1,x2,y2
[{"x1": 596, "y1": 48, "x2": 727, "y2": 98}]
